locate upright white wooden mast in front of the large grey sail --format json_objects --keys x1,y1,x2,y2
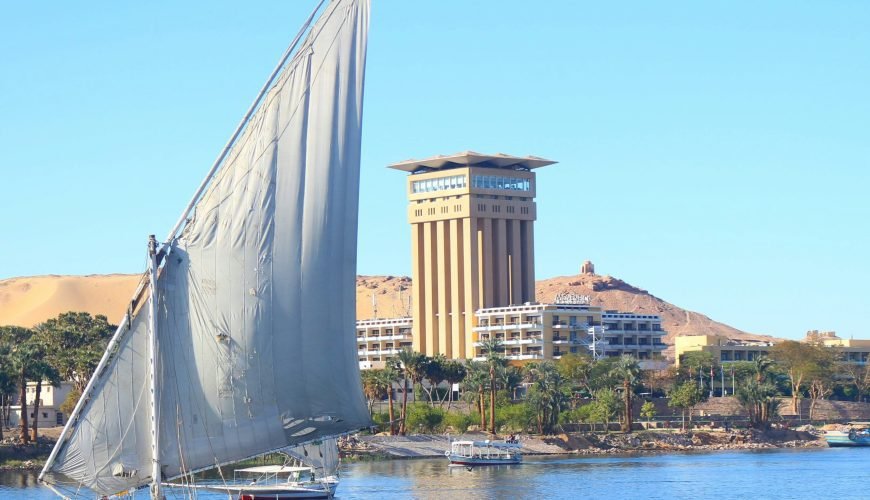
[{"x1": 148, "y1": 234, "x2": 163, "y2": 500}]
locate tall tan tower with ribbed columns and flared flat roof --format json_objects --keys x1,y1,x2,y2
[{"x1": 389, "y1": 151, "x2": 555, "y2": 358}]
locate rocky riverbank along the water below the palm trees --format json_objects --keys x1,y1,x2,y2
[{"x1": 342, "y1": 427, "x2": 827, "y2": 460}]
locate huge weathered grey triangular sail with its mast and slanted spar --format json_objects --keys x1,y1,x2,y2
[{"x1": 39, "y1": 0, "x2": 369, "y2": 498}]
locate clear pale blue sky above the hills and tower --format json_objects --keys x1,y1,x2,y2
[{"x1": 0, "y1": 0, "x2": 870, "y2": 338}]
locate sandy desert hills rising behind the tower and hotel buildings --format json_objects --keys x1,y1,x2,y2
[{"x1": 0, "y1": 274, "x2": 769, "y2": 352}]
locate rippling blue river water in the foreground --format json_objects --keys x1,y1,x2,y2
[{"x1": 0, "y1": 448, "x2": 870, "y2": 500}]
